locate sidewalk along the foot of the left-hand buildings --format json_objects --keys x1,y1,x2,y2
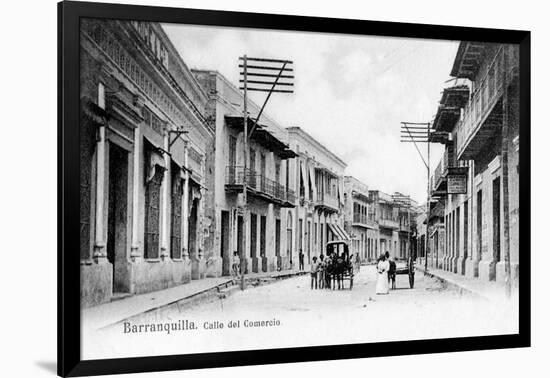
[{"x1": 81, "y1": 270, "x2": 305, "y2": 330}]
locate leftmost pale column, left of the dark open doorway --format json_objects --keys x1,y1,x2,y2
[{"x1": 93, "y1": 125, "x2": 107, "y2": 263}]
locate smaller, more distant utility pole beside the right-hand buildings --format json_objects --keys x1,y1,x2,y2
[{"x1": 401, "y1": 122, "x2": 431, "y2": 273}]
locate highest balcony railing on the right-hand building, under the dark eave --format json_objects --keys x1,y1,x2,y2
[{"x1": 457, "y1": 45, "x2": 519, "y2": 156}]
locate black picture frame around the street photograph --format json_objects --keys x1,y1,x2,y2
[{"x1": 58, "y1": 1, "x2": 531, "y2": 376}]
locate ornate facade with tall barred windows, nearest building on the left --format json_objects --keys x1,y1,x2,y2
[{"x1": 80, "y1": 19, "x2": 214, "y2": 307}]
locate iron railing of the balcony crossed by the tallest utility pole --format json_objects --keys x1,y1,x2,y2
[{"x1": 225, "y1": 166, "x2": 296, "y2": 204}]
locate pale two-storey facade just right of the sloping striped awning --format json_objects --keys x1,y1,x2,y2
[{"x1": 344, "y1": 176, "x2": 379, "y2": 262}]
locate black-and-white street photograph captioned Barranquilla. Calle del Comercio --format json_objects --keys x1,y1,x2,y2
[{"x1": 78, "y1": 18, "x2": 529, "y2": 360}]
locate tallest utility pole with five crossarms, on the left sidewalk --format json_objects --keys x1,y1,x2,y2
[{"x1": 239, "y1": 54, "x2": 294, "y2": 290}]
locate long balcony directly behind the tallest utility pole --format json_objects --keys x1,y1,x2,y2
[{"x1": 225, "y1": 166, "x2": 296, "y2": 207}]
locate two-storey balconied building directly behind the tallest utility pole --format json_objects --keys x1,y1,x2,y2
[{"x1": 194, "y1": 70, "x2": 296, "y2": 276}]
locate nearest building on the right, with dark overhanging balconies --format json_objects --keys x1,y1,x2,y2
[{"x1": 431, "y1": 42, "x2": 519, "y2": 281}]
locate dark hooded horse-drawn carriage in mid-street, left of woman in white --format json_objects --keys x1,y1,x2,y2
[{"x1": 325, "y1": 240, "x2": 354, "y2": 290}]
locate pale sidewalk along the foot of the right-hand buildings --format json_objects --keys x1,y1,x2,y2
[{"x1": 415, "y1": 265, "x2": 518, "y2": 302}]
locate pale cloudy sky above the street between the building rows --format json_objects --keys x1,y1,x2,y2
[{"x1": 163, "y1": 24, "x2": 458, "y2": 203}]
